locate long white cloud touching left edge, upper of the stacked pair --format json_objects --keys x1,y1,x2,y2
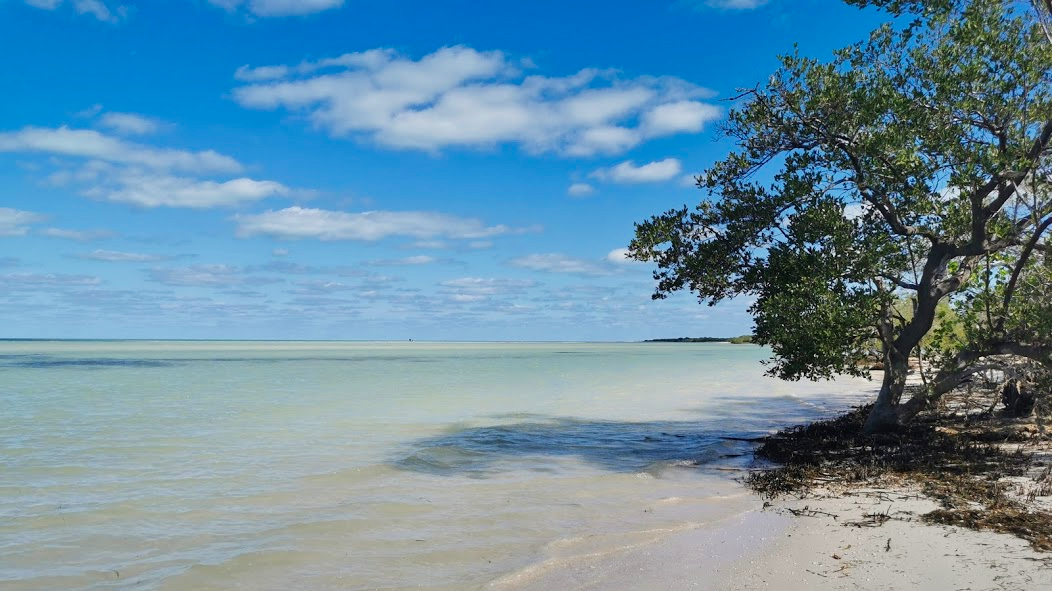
[{"x1": 0, "y1": 126, "x2": 242, "y2": 174}]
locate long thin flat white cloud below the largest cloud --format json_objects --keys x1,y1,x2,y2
[{"x1": 234, "y1": 206, "x2": 535, "y2": 241}]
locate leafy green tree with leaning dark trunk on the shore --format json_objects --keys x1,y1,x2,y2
[{"x1": 630, "y1": 0, "x2": 1052, "y2": 430}]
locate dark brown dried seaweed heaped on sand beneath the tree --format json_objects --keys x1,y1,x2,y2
[{"x1": 746, "y1": 393, "x2": 1052, "y2": 552}]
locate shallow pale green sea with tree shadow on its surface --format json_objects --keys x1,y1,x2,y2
[{"x1": 0, "y1": 341, "x2": 875, "y2": 591}]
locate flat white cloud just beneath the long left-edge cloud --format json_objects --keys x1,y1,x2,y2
[{"x1": 84, "y1": 169, "x2": 290, "y2": 209}]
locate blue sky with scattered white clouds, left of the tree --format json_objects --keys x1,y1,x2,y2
[{"x1": 0, "y1": 0, "x2": 882, "y2": 341}]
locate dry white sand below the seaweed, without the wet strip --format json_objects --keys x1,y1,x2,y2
[{"x1": 715, "y1": 491, "x2": 1052, "y2": 591}]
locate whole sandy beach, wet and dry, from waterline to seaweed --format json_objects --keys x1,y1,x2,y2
[{"x1": 493, "y1": 483, "x2": 1052, "y2": 591}]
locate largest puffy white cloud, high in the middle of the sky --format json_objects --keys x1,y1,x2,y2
[{"x1": 234, "y1": 46, "x2": 720, "y2": 156}]
